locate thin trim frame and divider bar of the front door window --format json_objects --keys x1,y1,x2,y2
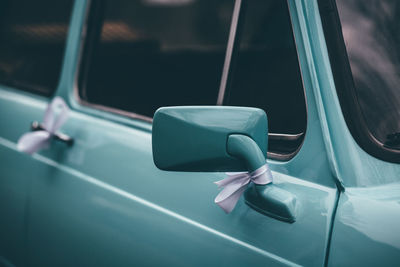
[{"x1": 73, "y1": 0, "x2": 308, "y2": 161}]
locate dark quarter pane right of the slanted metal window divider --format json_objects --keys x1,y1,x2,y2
[{"x1": 224, "y1": 0, "x2": 307, "y2": 137}]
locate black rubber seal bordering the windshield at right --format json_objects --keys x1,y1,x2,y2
[{"x1": 318, "y1": 0, "x2": 400, "y2": 163}]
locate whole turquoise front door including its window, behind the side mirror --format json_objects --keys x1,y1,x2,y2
[{"x1": 2, "y1": 1, "x2": 338, "y2": 266}]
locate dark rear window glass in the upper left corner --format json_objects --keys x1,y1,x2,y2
[{"x1": 0, "y1": 0, "x2": 73, "y2": 96}]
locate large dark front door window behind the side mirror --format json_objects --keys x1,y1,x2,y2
[{"x1": 78, "y1": 0, "x2": 307, "y2": 159}]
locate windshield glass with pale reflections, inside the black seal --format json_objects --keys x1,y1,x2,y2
[{"x1": 337, "y1": 0, "x2": 400, "y2": 149}]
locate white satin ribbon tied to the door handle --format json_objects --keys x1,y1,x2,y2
[{"x1": 17, "y1": 97, "x2": 69, "y2": 154}]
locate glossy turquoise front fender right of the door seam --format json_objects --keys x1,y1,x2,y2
[{"x1": 329, "y1": 183, "x2": 400, "y2": 266}]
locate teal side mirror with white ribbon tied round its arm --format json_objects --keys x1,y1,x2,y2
[{"x1": 152, "y1": 106, "x2": 296, "y2": 222}]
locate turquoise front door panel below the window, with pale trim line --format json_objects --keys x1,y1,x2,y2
[{"x1": 1, "y1": 90, "x2": 336, "y2": 266}]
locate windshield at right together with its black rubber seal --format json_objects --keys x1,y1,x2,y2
[{"x1": 319, "y1": 0, "x2": 400, "y2": 163}]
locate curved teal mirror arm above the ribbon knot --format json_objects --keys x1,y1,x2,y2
[{"x1": 226, "y1": 134, "x2": 266, "y2": 172}]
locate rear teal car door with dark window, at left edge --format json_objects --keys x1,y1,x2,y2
[{"x1": 0, "y1": 1, "x2": 72, "y2": 266}]
